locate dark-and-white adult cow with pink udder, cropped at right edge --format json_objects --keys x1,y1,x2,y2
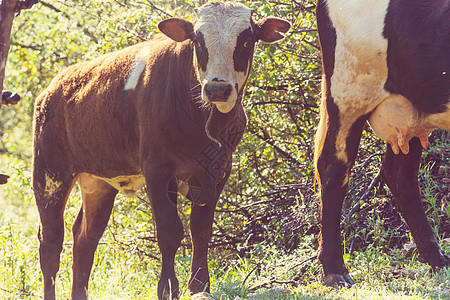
[{"x1": 315, "y1": 0, "x2": 450, "y2": 284}]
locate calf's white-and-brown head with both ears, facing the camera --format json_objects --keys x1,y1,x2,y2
[{"x1": 158, "y1": 2, "x2": 291, "y2": 113}]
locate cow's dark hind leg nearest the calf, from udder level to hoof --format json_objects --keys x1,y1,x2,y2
[{"x1": 315, "y1": 103, "x2": 366, "y2": 285}]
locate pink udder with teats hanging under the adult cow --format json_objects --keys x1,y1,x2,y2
[{"x1": 369, "y1": 94, "x2": 450, "y2": 154}]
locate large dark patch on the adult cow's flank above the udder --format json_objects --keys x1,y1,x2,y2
[{"x1": 383, "y1": 0, "x2": 450, "y2": 113}]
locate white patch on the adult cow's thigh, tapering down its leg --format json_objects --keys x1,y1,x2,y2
[{"x1": 327, "y1": 0, "x2": 389, "y2": 162}]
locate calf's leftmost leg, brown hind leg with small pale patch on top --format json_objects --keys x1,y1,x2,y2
[{"x1": 33, "y1": 170, "x2": 74, "y2": 300}]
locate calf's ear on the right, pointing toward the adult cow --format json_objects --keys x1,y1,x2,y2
[{"x1": 257, "y1": 17, "x2": 291, "y2": 44}]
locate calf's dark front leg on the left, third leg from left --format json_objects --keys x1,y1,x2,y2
[{"x1": 144, "y1": 164, "x2": 183, "y2": 300}]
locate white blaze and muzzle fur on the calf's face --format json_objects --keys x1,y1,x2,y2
[{"x1": 194, "y1": 2, "x2": 255, "y2": 113}]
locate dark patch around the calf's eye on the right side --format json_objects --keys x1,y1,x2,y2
[{"x1": 233, "y1": 28, "x2": 255, "y2": 73}]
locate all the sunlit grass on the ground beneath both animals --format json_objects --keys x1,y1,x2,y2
[{"x1": 0, "y1": 192, "x2": 450, "y2": 300}]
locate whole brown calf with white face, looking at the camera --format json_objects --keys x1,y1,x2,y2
[{"x1": 32, "y1": 2, "x2": 290, "y2": 299}]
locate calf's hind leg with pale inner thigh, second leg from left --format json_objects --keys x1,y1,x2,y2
[{"x1": 72, "y1": 174, "x2": 117, "y2": 299}]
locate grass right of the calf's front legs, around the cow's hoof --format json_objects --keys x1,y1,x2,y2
[{"x1": 207, "y1": 246, "x2": 450, "y2": 299}]
